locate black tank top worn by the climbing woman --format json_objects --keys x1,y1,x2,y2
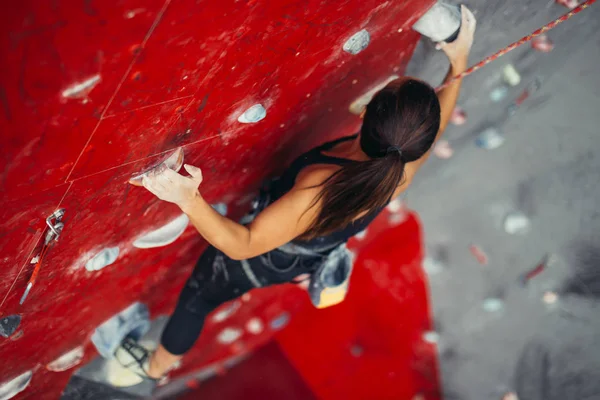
[{"x1": 269, "y1": 135, "x2": 383, "y2": 250}]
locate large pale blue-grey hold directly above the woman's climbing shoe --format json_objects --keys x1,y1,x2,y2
[{"x1": 92, "y1": 302, "x2": 150, "y2": 358}]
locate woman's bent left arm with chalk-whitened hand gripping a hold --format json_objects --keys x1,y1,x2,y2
[{"x1": 135, "y1": 165, "x2": 320, "y2": 260}]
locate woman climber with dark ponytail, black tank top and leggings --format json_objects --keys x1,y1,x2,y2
[{"x1": 115, "y1": 6, "x2": 476, "y2": 379}]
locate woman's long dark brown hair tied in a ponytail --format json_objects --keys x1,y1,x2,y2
[{"x1": 301, "y1": 78, "x2": 440, "y2": 240}]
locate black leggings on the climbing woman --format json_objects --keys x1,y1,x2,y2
[{"x1": 161, "y1": 246, "x2": 321, "y2": 355}]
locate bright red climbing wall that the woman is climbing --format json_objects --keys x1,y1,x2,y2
[{"x1": 0, "y1": 0, "x2": 433, "y2": 399}]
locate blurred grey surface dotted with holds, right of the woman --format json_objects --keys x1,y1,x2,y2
[{"x1": 406, "y1": 0, "x2": 600, "y2": 400}]
